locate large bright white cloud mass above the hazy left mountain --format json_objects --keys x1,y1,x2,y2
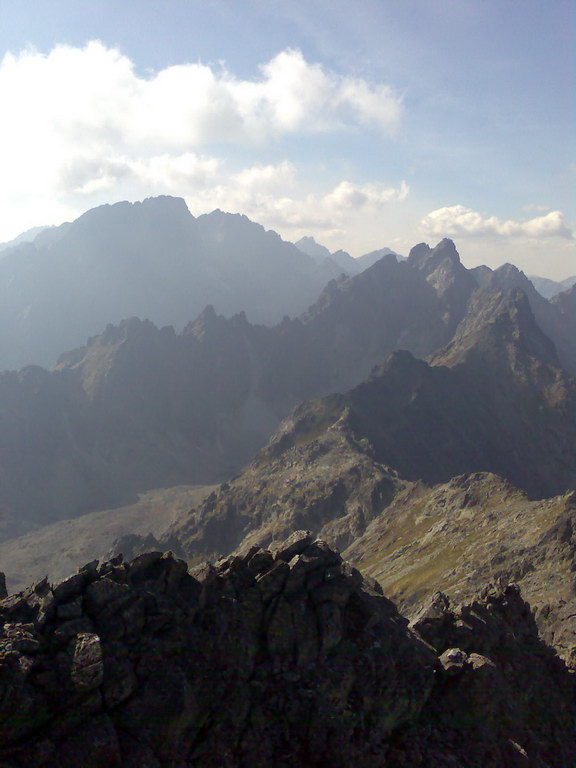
[{"x1": 0, "y1": 42, "x2": 402, "y2": 239}]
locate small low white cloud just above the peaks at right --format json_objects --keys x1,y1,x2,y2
[{"x1": 420, "y1": 205, "x2": 573, "y2": 239}]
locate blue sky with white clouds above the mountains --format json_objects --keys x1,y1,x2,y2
[{"x1": 0, "y1": 0, "x2": 576, "y2": 279}]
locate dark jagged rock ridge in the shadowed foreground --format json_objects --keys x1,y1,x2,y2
[{"x1": 0, "y1": 531, "x2": 576, "y2": 768}]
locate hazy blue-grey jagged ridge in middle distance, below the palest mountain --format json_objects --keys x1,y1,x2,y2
[{"x1": 0, "y1": 237, "x2": 482, "y2": 536}]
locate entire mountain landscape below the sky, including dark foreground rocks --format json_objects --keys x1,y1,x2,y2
[{"x1": 0, "y1": 198, "x2": 576, "y2": 768}]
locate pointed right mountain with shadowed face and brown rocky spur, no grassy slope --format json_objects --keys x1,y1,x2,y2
[{"x1": 173, "y1": 284, "x2": 576, "y2": 568}]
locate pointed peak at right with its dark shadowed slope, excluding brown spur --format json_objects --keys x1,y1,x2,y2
[{"x1": 267, "y1": 292, "x2": 576, "y2": 496}]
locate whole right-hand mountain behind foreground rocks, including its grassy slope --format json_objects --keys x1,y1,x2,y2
[{"x1": 166, "y1": 282, "x2": 576, "y2": 665}]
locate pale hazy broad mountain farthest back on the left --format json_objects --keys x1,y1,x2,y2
[{"x1": 0, "y1": 197, "x2": 340, "y2": 370}]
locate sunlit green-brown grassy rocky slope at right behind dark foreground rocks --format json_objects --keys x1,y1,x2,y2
[{"x1": 345, "y1": 473, "x2": 576, "y2": 668}]
